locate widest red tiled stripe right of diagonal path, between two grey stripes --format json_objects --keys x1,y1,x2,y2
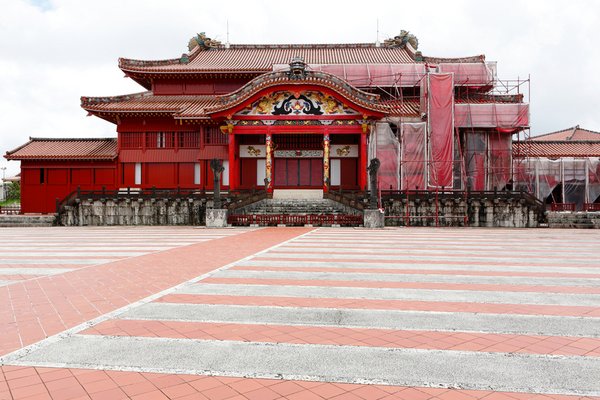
[{"x1": 81, "y1": 320, "x2": 600, "y2": 357}]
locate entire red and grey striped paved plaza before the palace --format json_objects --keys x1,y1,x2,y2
[{"x1": 0, "y1": 227, "x2": 600, "y2": 400}]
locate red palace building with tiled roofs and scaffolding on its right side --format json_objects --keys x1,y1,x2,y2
[{"x1": 5, "y1": 31, "x2": 529, "y2": 213}]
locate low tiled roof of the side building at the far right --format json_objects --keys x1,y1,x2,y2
[{"x1": 513, "y1": 140, "x2": 600, "y2": 158}]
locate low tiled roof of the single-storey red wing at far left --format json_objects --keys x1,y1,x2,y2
[{"x1": 4, "y1": 138, "x2": 117, "y2": 160}]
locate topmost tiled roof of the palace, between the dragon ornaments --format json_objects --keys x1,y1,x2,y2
[{"x1": 119, "y1": 43, "x2": 415, "y2": 73}]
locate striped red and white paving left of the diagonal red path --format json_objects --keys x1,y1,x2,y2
[{"x1": 0, "y1": 227, "x2": 248, "y2": 286}]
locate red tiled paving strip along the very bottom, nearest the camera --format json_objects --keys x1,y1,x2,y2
[{"x1": 0, "y1": 366, "x2": 599, "y2": 400}]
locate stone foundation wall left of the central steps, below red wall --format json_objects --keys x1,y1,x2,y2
[{"x1": 59, "y1": 198, "x2": 212, "y2": 226}]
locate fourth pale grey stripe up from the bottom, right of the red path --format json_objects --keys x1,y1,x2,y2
[{"x1": 212, "y1": 270, "x2": 600, "y2": 291}]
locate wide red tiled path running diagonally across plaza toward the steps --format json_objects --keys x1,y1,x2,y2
[{"x1": 0, "y1": 228, "x2": 311, "y2": 355}]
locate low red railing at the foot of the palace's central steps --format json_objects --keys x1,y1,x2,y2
[{"x1": 227, "y1": 214, "x2": 363, "y2": 226}]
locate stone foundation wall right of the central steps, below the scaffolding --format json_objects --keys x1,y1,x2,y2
[{"x1": 385, "y1": 198, "x2": 543, "y2": 228}]
